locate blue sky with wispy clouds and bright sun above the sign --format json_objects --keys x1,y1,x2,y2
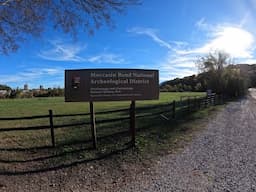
[{"x1": 0, "y1": 0, "x2": 256, "y2": 88}]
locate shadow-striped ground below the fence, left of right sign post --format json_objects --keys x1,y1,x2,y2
[{"x1": 0, "y1": 124, "x2": 135, "y2": 175}]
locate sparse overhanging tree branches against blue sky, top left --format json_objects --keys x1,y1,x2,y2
[{"x1": 0, "y1": 0, "x2": 139, "y2": 54}]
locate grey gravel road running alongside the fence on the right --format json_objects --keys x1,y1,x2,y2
[{"x1": 120, "y1": 90, "x2": 256, "y2": 192}]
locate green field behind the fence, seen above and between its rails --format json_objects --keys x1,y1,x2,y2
[{"x1": 0, "y1": 92, "x2": 205, "y2": 147}]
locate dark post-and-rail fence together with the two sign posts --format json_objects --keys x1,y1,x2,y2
[{"x1": 0, "y1": 94, "x2": 223, "y2": 149}]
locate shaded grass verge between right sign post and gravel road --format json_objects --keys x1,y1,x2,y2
[{"x1": 136, "y1": 105, "x2": 223, "y2": 158}]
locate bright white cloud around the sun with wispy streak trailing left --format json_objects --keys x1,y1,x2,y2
[{"x1": 128, "y1": 22, "x2": 256, "y2": 81}]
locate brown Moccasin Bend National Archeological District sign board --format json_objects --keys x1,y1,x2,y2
[{"x1": 65, "y1": 69, "x2": 159, "y2": 102}]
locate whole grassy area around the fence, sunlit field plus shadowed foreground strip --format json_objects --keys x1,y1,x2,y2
[{"x1": 0, "y1": 92, "x2": 210, "y2": 175}]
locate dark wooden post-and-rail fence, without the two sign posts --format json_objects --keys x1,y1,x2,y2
[{"x1": 0, "y1": 94, "x2": 223, "y2": 147}]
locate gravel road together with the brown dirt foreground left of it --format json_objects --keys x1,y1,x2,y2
[{"x1": 0, "y1": 90, "x2": 256, "y2": 192}]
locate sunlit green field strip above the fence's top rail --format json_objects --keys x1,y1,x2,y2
[{"x1": 0, "y1": 92, "x2": 205, "y2": 117}]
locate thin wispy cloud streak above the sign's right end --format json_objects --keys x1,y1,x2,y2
[{"x1": 128, "y1": 27, "x2": 172, "y2": 50}]
